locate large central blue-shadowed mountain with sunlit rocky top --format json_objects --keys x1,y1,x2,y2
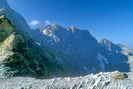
[{"x1": 42, "y1": 24, "x2": 101, "y2": 73}]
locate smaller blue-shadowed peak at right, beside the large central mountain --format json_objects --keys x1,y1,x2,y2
[{"x1": 99, "y1": 39, "x2": 130, "y2": 72}]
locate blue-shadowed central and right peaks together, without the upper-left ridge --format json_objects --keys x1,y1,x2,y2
[{"x1": 35, "y1": 24, "x2": 130, "y2": 73}]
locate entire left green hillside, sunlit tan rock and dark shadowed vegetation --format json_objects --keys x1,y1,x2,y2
[{"x1": 0, "y1": 17, "x2": 63, "y2": 77}]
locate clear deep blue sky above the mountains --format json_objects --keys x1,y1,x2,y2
[{"x1": 8, "y1": 0, "x2": 133, "y2": 48}]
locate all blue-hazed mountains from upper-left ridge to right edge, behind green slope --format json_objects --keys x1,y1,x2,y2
[{"x1": 0, "y1": 0, "x2": 132, "y2": 74}]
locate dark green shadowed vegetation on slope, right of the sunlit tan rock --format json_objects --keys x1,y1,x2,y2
[{"x1": 5, "y1": 34, "x2": 62, "y2": 76}]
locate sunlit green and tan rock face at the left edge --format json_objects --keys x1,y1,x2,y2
[{"x1": 0, "y1": 15, "x2": 15, "y2": 61}]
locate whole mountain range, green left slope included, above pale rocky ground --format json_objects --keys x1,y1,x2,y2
[{"x1": 0, "y1": 0, "x2": 133, "y2": 88}]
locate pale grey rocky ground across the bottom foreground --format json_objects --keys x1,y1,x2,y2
[{"x1": 0, "y1": 72, "x2": 133, "y2": 89}]
